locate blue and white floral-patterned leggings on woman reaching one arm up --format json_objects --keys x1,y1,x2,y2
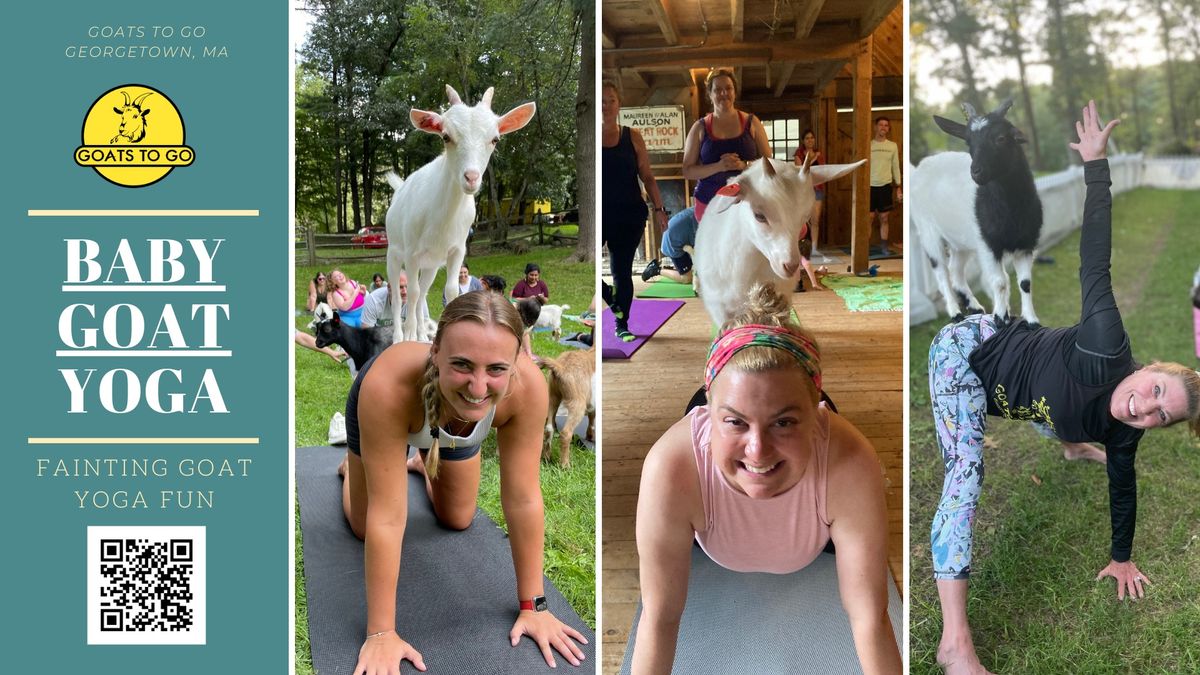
[{"x1": 929, "y1": 315, "x2": 996, "y2": 579}]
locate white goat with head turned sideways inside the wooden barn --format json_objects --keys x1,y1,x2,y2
[{"x1": 696, "y1": 159, "x2": 866, "y2": 325}]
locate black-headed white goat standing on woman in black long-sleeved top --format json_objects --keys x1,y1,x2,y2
[{"x1": 911, "y1": 98, "x2": 1042, "y2": 324}]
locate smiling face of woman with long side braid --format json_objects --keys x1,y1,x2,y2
[{"x1": 431, "y1": 321, "x2": 520, "y2": 422}]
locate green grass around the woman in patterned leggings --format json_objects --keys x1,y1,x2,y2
[{"x1": 908, "y1": 190, "x2": 1200, "y2": 674}]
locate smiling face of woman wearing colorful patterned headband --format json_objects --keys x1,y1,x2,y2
[{"x1": 708, "y1": 366, "x2": 816, "y2": 498}]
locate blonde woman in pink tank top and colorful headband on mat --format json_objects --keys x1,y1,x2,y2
[{"x1": 632, "y1": 286, "x2": 901, "y2": 675}]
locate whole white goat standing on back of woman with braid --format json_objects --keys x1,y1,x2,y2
[{"x1": 386, "y1": 84, "x2": 538, "y2": 342}]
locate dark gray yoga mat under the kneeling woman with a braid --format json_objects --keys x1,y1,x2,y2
[{"x1": 296, "y1": 447, "x2": 595, "y2": 675}]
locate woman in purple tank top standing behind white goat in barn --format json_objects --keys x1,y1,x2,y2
[{"x1": 683, "y1": 68, "x2": 770, "y2": 220}]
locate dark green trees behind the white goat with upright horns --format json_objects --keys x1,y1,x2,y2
[{"x1": 295, "y1": 0, "x2": 595, "y2": 261}]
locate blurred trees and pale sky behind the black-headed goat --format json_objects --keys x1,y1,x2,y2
[{"x1": 910, "y1": 0, "x2": 1200, "y2": 166}]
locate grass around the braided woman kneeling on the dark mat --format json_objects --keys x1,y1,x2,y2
[{"x1": 294, "y1": 247, "x2": 595, "y2": 675}]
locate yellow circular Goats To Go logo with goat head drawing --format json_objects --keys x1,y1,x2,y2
[{"x1": 74, "y1": 84, "x2": 196, "y2": 187}]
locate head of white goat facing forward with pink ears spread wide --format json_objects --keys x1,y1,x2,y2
[{"x1": 409, "y1": 84, "x2": 538, "y2": 195}]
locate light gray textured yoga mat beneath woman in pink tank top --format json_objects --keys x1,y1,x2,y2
[{"x1": 620, "y1": 545, "x2": 902, "y2": 675}]
